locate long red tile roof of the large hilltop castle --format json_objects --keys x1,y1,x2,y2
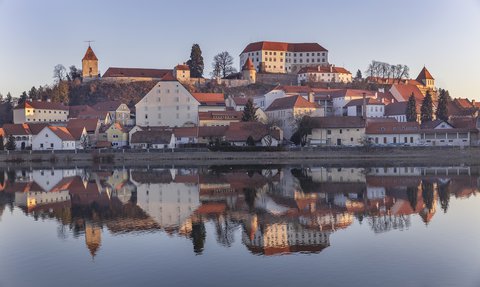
[{"x1": 242, "y1": 41, "x2": 327, "y2": 54}]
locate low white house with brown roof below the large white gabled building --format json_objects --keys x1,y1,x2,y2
[{"x1": 130, "y1": 130, "x2": 175, "y2": 149}]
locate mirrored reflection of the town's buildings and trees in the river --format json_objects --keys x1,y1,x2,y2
[{"x1": 0, "y1": 167, "x2": 478, "y2": 257}]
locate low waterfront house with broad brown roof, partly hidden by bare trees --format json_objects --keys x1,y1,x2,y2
[{"x1": 224, "y1": 122, "x2": 283, "y2": 146}]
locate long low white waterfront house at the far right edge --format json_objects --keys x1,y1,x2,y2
[{"x1": 420, "y1": 120, "x2": 478, "y2": 146}]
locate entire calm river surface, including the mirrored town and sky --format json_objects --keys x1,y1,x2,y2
[{"x1": 0, "y1": 166, "x2": 480, "y2": 287}]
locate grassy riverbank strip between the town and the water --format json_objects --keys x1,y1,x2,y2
[{"x1": 0, "y1": 147, "x2": 480, "y2": 168}]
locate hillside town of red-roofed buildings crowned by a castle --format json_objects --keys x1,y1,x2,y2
[{"x1": 0, "y1": 41, "x2": 480, "y2": 151}]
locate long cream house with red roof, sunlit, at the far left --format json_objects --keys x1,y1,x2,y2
[{"x1": 13, "y1": 101, "x2": 68, "y2": 124}]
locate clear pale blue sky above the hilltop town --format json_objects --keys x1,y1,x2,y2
[{"x1": 0, "y1": 0, "x2": 480, "y2": 101}]
